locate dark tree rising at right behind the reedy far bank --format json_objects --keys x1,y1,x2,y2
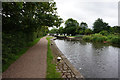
[{"x1": 93, "y1": 18, "x2": 110, "y2": 33}]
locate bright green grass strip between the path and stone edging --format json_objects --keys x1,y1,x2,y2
[{"x1": 46, "y1": 37, "x2": 61, "y2": 78}]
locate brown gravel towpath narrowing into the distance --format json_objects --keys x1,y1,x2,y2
[{"x1": 2, "y1": 37, "x2": 47, "y2": 78}]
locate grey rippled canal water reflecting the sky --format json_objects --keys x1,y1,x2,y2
[{"x1": 55, "y1": 39, "x2": 120, "y2": 78}]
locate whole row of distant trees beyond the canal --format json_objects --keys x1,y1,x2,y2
[{"x1": 49, "y1": 18, "x2": 120, "y2": 36}]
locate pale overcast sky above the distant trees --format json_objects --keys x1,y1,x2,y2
[{"x1": 54, "y1": 0, "x2": 119, "y2": 28}]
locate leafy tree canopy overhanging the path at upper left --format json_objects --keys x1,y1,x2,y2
[{"x1": 2, "y1": 1, "x2": 63, "y2": 33}]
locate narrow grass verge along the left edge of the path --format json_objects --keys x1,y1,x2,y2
[{"x1": 2, "y1": 37, "x2": 42, "y2": 72}]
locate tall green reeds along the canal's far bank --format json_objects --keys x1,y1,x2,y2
[{"x1": 83, "y1": 33, "x2": 120, "y2": 45}]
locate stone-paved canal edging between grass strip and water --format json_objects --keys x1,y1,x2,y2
[{"x1": 51, "y1": 38, "x2": 84, "y2": 79}]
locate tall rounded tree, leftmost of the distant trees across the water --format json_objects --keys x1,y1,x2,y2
[{"x1": 65, "y1": 18, "x2": 79, "y2": 35}]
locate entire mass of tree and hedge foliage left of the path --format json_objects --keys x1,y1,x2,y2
[{"x1": 2, "y1": 1, "x2": 62, "y2": 72}]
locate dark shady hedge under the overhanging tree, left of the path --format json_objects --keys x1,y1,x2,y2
[{"x1": 2, "y1": 31, "x2": 43, "y2": 71}]
